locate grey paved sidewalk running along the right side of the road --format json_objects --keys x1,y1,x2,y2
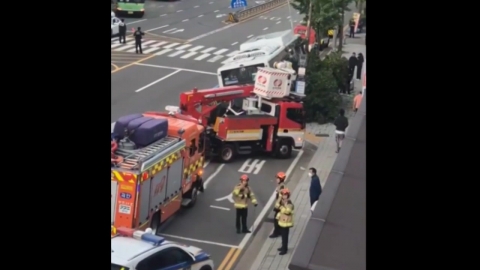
[{"x1": 242, "y1": 43, "x2": 366, "y2": 270}]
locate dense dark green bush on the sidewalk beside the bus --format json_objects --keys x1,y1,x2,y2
[{"x1": 305, "y1": 53, "x2": 348, "y2": 123}]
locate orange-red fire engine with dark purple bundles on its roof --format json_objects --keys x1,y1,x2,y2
[{"x1": 111, "y1": 112, "x2": 204, "y2": 233}]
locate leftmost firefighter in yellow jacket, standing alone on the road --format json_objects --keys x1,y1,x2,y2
[{"x1": 232, "y1": 174, "x2": 257, "y2": 233}]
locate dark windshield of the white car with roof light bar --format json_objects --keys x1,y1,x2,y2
[{"x1": 136, "y1": 248, "x2": 193, "y2": 270}]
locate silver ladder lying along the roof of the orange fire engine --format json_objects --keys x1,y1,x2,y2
[{"x1": 120, "y1": 137, "x2": 178, "y2": 170}]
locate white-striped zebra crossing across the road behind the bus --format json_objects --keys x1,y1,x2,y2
[{"x1": 111, "y1": 38, "x2": 239, "y2": 64}]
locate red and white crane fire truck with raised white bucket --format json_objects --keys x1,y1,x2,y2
[{"x1": 174, "y1": 65, "x2": 305, "y2": 162}]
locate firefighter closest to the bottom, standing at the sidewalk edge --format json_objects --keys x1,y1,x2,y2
[{"x1": 275, "y1": 188, "x2": 294, "y2": 255}]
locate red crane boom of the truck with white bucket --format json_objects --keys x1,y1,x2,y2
[{"x1": 179, "y1": 85, "x2": 254, "y2": 123}]
